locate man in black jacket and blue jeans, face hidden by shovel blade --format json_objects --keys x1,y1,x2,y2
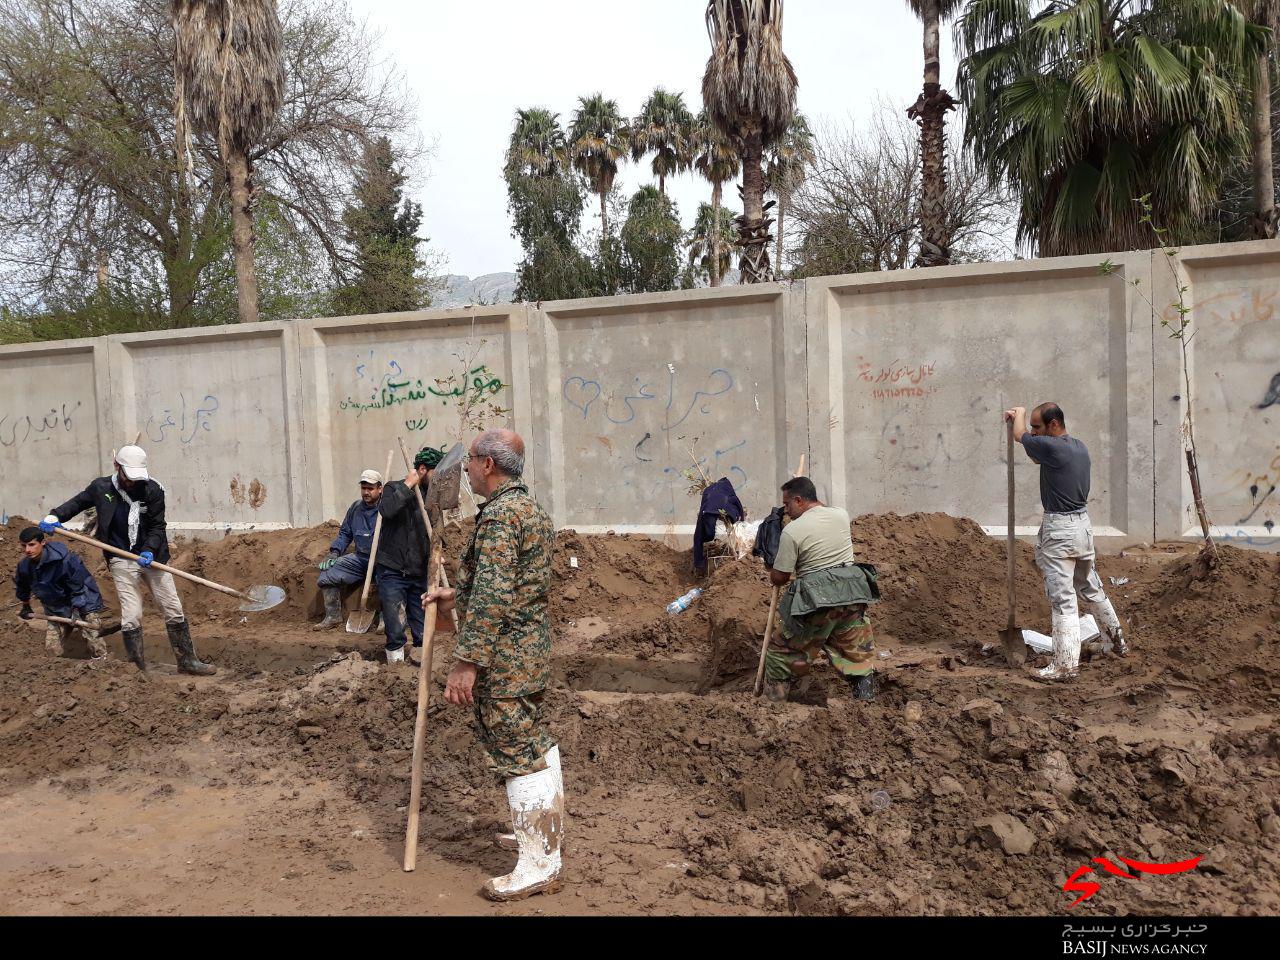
[{"x1": 374, "y1": 447, "x2": 444, "y2": 663}]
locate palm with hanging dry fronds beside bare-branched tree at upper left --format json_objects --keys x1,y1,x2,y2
[{"x1": 173, "y1": 0, "x2": 284, "y2": 324}]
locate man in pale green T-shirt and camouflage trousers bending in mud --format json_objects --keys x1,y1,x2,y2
[{"x1": 764, "y1": 476, "x2": 879, "y2": 700}]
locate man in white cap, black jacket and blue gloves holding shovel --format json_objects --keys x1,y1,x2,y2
[{"x1": 40, "y1": 444, "x2": 218, "y2": 676}]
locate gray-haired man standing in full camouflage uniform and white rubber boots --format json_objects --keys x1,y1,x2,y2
[{"x1": 424, "y1": 430, "x2": 564, "y2": 900}]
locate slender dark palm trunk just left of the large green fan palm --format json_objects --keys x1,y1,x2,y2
[{"x1": 906, "y1": 0, "x2": 961, "y2": 266}]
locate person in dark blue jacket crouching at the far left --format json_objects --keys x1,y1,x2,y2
[{"x1": 13, "y1": 526, "x2": 106, "y2": 659}]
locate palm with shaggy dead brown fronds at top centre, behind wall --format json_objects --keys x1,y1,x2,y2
[{"x1": 703, "y1": 0, "x2": 796, "y2": 283}]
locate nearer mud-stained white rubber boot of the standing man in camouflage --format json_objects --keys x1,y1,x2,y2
[{"x1": 484, "y1": 765, "x2": 564, "y2": 901}]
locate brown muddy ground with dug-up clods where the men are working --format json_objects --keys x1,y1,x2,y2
[{"x1": 0, "y1": 515, "x2": 1280, "y2": 916}]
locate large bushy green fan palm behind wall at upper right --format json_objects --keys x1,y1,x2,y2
[{"x1": 959, "y1": 0, "x2": 1266, "y2": 256}]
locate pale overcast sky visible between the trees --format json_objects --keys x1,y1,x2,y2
[{"x1": 351, "y1": 0, "x2": 955, "y2": 276}]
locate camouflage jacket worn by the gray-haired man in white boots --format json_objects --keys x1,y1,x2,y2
[{"x1": 453, "y1": 480, "x2": 553, "y2": 698}]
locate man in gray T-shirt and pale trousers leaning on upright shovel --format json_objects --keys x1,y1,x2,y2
[{"x1": 1005, "y1": 403, "x2": 1128, "y2": 680}]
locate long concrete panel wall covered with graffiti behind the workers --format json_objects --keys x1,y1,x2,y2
[{"x1": 0, "y1": 236, "x2": 1280, "y2": 549}]
